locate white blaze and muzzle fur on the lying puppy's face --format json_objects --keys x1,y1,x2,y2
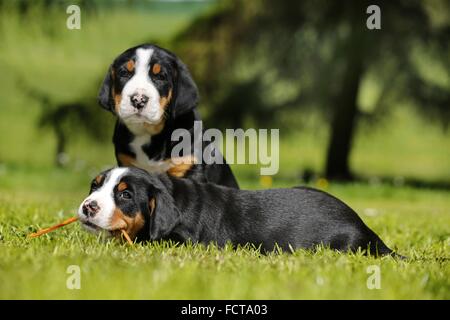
[{"x1": 78, "y1": 168, "x2": 128, "y2": 229}]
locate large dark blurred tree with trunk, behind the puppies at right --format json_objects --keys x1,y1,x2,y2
[{"x1": 173, "y1": 0, "x2": 450, "y2": 180}]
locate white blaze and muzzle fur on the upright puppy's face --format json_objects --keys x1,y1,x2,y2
[{"x1": 118, "y1": 48, "x2": 164, "y2": 131}]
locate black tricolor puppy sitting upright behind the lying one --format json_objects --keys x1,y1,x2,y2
[{"x1": 98, "y1": 44, "x2": 238, "y2": 188}]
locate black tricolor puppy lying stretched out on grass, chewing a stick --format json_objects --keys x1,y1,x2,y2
[{"x1": 78, "y1": 167, "x2": 400, "y2": 255}]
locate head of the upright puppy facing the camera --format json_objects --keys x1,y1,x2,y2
[{"x1": 98, "y1": 45, "x2": 198, "y2": 134}]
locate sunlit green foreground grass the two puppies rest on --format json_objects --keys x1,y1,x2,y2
[{"x1": 0, "y1": 173, "x2": 450, "y2": 299}]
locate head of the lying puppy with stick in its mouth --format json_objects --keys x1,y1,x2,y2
[{"x1": 78, "y1": 167, "x2": 178, "y2": 240}]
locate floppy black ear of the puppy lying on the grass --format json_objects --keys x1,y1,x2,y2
[{"x1": 149, "y1": 184, "x2": 180, "y2": 240}]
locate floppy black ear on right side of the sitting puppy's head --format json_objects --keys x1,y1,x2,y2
[{"x1": 172, "y1": 58, "x2": 199, "y2": 118}]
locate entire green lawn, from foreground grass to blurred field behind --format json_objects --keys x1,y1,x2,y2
[{"x1": 0, "y1": 1, "x2": 450, "y2": 299}]
